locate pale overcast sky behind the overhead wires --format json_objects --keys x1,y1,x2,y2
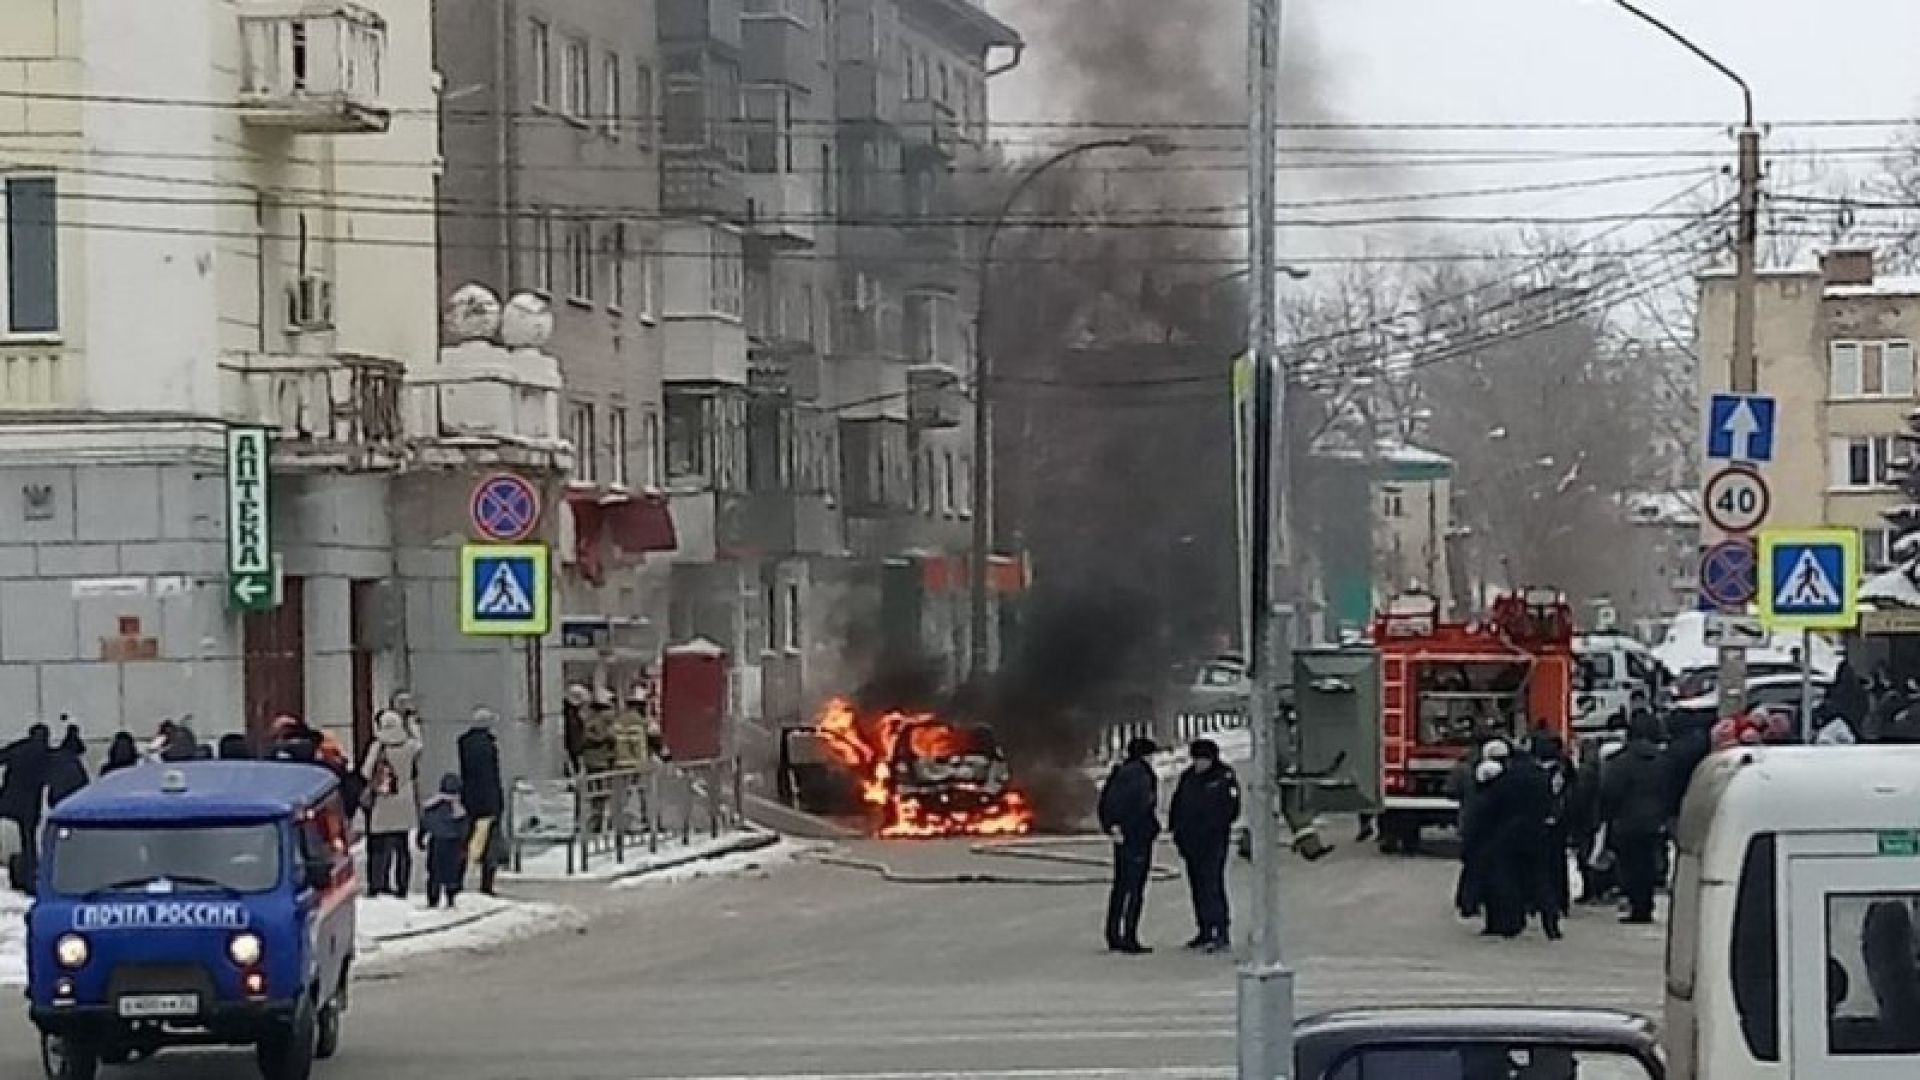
[{"x1": 991, "y1": 0, "x2": 1920, "y2": 259}]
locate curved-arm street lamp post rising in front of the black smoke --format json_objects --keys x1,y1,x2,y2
[{"x1": 968, "y1": 135, "x2": 1173, "y2": 678}]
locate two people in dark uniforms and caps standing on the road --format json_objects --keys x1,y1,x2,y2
[{"x1": 1100, "y1": 738, "x2": 1240, "y2": 955}]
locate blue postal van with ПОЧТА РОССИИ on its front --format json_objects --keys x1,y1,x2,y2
[{"x1": 27, "y1": 761, "x2": 359, "y2": 1080}]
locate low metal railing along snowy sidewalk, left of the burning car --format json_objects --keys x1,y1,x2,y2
[{"x1": 509, "y1": 759, "x2": 745, "y2": 874}]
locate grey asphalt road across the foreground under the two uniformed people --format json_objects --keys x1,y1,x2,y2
[{"x1": 0, "y1": 842, "x2": 1661, "y2": 1080}]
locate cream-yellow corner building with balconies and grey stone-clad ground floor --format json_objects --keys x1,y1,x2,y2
[{"x1": 0, "y1": 0, "x2": 566, "y2": 760}]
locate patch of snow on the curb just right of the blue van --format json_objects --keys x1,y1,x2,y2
[{"x1": 357, "y1": 892, "x2": 580, "y2": 970}]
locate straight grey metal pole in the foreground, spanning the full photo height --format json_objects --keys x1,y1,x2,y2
[{"x1": 1238, "y1": 0, "x2": 1294, "y2": 1080}]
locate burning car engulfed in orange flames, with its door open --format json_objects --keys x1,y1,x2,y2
[{"x1": 781, "y1": 700, "x2": 1033, "y2": 836}]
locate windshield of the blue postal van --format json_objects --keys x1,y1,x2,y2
[{"x1": 52, "y1": 822, "x2": 280, "y2": 896}]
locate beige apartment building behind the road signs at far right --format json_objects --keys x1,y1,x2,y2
[{"x1": 1699, "y1": 248, "x2": 1920, "y2": 569}]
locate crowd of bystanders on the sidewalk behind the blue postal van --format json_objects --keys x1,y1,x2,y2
[{"x1": 0, "y1": 692, "x2": 507, "y2": 907}]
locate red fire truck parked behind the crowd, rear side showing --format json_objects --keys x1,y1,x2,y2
[{"x1": 1373, "y1": 588, "x2": 1574, "y2": 851}]
